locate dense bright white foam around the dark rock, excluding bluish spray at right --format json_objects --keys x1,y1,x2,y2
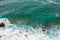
[{"x1": 0, "y1": 18, "x2": 60, "y2": 40}]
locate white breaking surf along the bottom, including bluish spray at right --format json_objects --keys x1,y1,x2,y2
[{"x1": 0, "y1": 18, "x2": 60, "y2": 40}]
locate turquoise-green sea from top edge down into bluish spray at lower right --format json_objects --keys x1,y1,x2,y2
[{"x1": 0, "y1": 0, "x2": 60, "y2": 40}]
